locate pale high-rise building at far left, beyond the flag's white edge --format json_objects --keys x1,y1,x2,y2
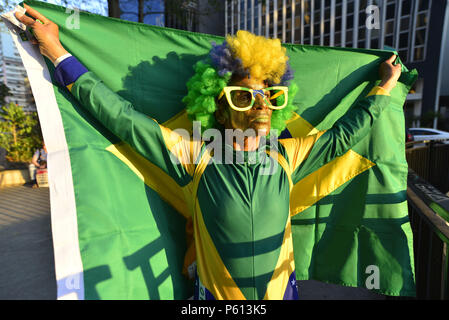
[{"x1": 0, "y1": 32, "x2": 36, "y2": 111}]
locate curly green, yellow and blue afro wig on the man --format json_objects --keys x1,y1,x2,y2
[{"x1": 182, "y1": 30, "x2": 298, "y2": 134}]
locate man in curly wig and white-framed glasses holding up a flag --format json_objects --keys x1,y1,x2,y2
[{"x1": 17, "y1": 5, "x2": 401, "y2": 299}]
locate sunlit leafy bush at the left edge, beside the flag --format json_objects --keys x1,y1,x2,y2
[{"x1": 0, "y1": 103, "x2": 42, "y2": 162}]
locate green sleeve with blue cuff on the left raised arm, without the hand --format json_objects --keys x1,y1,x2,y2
[{"x1": 55, "y1": 57, "x2": 194, "y2": 185}]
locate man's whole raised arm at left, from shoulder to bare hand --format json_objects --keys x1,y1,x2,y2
[{"x1": 16, "y1": 4, "x2": 200, "y2": 187}]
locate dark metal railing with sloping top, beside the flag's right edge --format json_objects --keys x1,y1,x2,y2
[{"x1": 407, "y1": 170, "x2": 449, "y2": 300}]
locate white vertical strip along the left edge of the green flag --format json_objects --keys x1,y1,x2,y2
[{"x1": 3, "y1": 19, "x2": 84, "y2": 300}]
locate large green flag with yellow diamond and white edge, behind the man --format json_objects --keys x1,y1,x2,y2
[{"x1": 4, "y1": 1, "x2": 417, "y2": 299}]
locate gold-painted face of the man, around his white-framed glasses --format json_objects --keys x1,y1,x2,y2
[{"x1": 216, "y1": 77, "x2": 273, "y2": 136}]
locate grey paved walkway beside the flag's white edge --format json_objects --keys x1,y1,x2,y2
[{"x1": 0, "y1": 186, "x2": 56, "y2": 300}]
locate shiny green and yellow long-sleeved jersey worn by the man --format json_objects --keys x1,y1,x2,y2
[{"x1": 63, "y1": 68, "x2": 390, "y2": 299}]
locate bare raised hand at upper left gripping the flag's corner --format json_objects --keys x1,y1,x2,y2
[{"x1": 15, "y1": 4, "x2": 68, "y2": 63}]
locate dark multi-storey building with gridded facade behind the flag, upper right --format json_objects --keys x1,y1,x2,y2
[{"x1": 225, "y1": 0, "x2": 449, "y2": 128}]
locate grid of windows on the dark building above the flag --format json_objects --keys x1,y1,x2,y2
[{"x1": 226, "y1": 0, "x2": 432, "y2": 62}]
